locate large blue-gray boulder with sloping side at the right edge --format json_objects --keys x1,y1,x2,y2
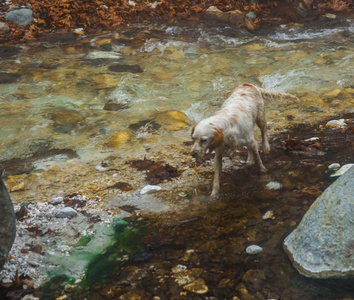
[{"x1": 283, "y1": 167, "x2": 354, "y2": 278}]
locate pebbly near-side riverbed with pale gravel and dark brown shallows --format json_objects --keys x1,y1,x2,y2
[{"x1": 1, "y1": 116, "x2": 353, "y2": 299}]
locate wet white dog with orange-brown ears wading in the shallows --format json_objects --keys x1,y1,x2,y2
[{"x1": 191, "y1": 83, "x2": 298, "y2": 196}]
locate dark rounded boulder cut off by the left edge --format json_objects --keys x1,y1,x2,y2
[{"x1": 0, "y1": 178, "x2": 16, "y2": 270}]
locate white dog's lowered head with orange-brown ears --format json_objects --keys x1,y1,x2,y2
[{"x1": 191, "y1": 121, "x2": 225, "y2": 158}]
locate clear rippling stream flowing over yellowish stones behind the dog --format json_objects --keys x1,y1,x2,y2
[{"x1": 0, "y1": 15, "x2": 354, "y2": 160}]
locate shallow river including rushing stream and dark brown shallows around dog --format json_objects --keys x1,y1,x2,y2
[{"x1": 0, "y1": 12, "x2": 354, "y2": 299}]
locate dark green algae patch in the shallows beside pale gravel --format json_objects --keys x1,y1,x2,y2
[{"x1": 40, "y1": 218, "x2": 145, "y2": 299}]
